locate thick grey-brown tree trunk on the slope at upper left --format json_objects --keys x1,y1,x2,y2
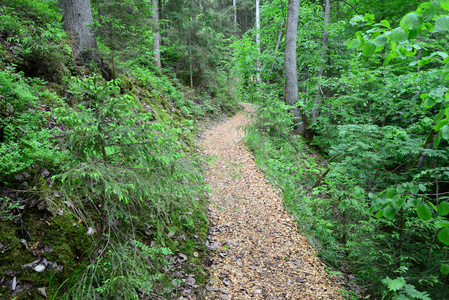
[{"x1": 60, "y1": 0, "x2": 100, "y2": 63}]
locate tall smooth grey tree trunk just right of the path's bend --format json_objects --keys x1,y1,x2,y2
[{"x1": 284, "y1": 0, "x2": 307, "y2": 135}]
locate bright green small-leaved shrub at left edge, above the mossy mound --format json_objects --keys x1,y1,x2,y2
[{"x1": 0, "y1": 68, "x2": 64, "y2": 175}]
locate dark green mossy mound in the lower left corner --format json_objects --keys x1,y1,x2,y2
[{"x1": 0, "y1": 209, "x2": 94, "y2": 299}]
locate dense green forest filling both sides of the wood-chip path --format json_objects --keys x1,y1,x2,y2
[{"x1": 0, "y1": 0, "x2": 449, "y2": 299}]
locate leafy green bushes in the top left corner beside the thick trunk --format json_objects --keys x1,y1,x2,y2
[{"x1": 0, "y1": 0, "x2": 71, "y2": 82}]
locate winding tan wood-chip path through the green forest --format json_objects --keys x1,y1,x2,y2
[{"x1": 201, "y1": 103, "x2": 342, "y2": 300}]
